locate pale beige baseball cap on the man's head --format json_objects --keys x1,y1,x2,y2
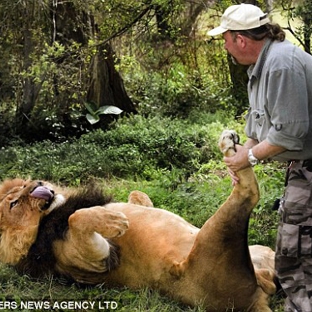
[{"x1": 208, "y1": 3, "x2": 270, "y2": 36}]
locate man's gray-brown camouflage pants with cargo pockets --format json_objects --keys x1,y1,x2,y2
[{"x1": 275, "y1": 162, "x2": 312, "y2": 312}]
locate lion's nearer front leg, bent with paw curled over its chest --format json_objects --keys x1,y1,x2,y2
[{"x1": 54, "y1": 206, "x2": 129, "y2": 282}]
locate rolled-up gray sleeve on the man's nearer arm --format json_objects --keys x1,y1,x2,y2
[{"x1": 266, "y1": 69, "x2": 309, "y2": 151}]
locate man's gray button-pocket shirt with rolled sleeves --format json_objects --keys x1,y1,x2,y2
[{"x1": 245, "y1": 39, "x2": 312, "y2": 161}]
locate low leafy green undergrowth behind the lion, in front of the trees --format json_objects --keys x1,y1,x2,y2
[{"x1": 0, "y1": 115, "x2": 233, "y2": 183}]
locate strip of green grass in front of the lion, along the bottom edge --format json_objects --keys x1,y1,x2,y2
[{"x1": 0, "y1": 265, "x2": 203, "y2": 312}]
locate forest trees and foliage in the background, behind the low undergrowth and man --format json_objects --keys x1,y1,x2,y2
[{"x1": 0, "y1": 0, "x2": 311, "y2": 146}]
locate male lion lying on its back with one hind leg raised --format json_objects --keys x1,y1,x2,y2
[{"x1": 0, "y1": 130, "x2": 276, "y2": 312}]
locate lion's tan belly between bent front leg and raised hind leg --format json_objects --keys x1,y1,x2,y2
[{"x1": 103, "y1": 203, "x2": 199, "y2": 288}]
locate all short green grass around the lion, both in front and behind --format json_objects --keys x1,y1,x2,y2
[{"x1": 0, "y1": 162, "x2": 282, "y2": 312}]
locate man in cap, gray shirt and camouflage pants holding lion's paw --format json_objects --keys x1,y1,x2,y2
[{"x1": 208, "y1": 4, "x2": 312, "y2": 312}]
